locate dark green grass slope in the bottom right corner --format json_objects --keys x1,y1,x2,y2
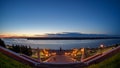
[{"x1": 88, "y1": 53, "x2": 120, "y2": 68}]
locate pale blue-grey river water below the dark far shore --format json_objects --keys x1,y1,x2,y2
[{"x1": 3, "y1": 39, "x2": 120, "y2": 49}]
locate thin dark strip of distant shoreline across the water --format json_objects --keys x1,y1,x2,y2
[{"x1": 26, "y1": 37, "x2": 120, "y2": 40}]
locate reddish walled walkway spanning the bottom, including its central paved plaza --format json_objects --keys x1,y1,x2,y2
[{"x1": 0, "y1": 46, "x2": 120, "y2": 68}]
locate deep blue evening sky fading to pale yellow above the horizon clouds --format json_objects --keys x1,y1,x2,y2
[{"x1": 0, "y1": 0, "x2": 120, "y2": 36}]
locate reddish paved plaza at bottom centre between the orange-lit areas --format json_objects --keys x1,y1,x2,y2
[{"x1": 46, "y1": 55, "x2": 75, "y2": 63}]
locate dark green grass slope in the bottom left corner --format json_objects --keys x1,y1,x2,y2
[{"x1": 0, "y1": 52, "x2": 31, "y2": 68}]
